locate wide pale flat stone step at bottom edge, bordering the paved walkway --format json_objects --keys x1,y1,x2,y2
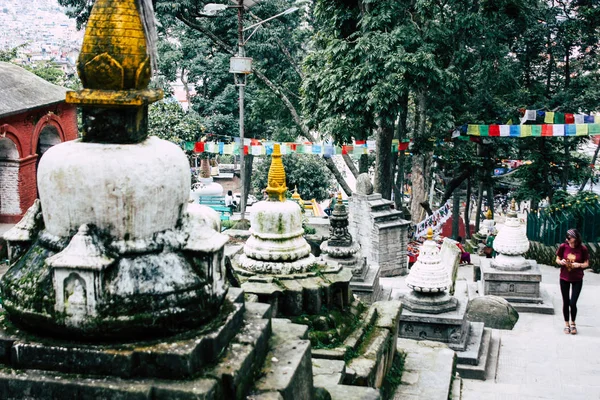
[{"x1": 392, "y1": 339, "x2": 456, "y2": 400}]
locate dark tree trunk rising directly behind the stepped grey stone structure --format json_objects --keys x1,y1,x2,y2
[{"x1": 374, "y1": 117, "x2": 394, "y2": 200}]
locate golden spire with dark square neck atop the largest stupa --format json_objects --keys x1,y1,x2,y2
[{"x1": 66, "y1": 0, "x2": 163, "y2": 143}]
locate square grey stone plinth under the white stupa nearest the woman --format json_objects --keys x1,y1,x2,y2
[{"x1": 479, "y1": 258, "x2": 554, "y2": 314}]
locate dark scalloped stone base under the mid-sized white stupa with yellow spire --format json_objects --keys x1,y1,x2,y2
[{"x1": 230, "y1": 254, "x2": 352, "y2": 316}]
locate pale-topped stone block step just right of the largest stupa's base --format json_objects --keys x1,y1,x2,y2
[{"x1": 250, "y1": 318, "x2": 314, "y2": 399}]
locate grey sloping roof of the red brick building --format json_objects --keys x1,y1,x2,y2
[{"x1": 0, "y1": 62, "x2": 67, "y2": 118}]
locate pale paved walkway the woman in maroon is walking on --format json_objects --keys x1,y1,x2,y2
[{"x1": 381, "y1": 256, "x2": 600, "y2": 400}]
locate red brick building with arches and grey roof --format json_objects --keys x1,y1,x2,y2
[{"x1": 0, "y1": 62, "x2": 77, "y2": 223}]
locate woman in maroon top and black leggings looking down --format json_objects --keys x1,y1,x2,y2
[{"x1": 556, "y1": 229, "x2": 590, "y2": 335}]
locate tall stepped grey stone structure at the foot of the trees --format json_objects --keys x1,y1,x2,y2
[{"x1": 348, "y1": 193, "x2": 410, "y2": 276}]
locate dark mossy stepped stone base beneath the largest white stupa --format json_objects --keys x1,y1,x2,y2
[{"x1": 0, "y1": 288, "x2": 313, "y2": 400}]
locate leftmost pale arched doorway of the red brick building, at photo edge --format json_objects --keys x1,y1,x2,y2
[{"x1": 0, "y1": 137, "x2": 21, "y2": 219}]
